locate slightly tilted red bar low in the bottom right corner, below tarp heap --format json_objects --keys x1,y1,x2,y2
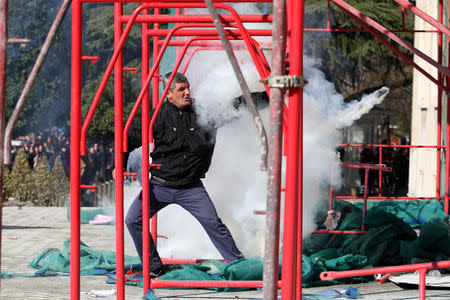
[{"x1": 320, "y1": 260, "x2": 450, "y2": 280}]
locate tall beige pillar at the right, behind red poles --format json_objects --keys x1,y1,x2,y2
[{"x1": 408, "y1": 0, "x2": 438, "y2": 196}]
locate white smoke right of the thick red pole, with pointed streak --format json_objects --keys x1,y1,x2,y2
[{"x1": 303, "y1": 56, "x2": 389, "y2": 236}]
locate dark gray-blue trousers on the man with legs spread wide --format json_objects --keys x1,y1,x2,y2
[{"x1": 125, "y1": 180, "x2": 244, "y2": 271}]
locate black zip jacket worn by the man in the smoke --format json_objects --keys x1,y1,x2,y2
[{"x1": 128, "y1": 92, "x2": 269, "y2": 188}]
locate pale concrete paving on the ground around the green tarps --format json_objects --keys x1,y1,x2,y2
[{"x1": 0, "y1": 206, "x2": 450, "y2": 300}]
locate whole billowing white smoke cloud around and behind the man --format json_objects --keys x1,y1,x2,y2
[{"x1": 125, "y1": 4, "x2": 388, "y2": 258}]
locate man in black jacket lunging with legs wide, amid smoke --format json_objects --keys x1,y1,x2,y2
[{"x1": 125, "y1": 73, "x2": 268, "y2": 277}]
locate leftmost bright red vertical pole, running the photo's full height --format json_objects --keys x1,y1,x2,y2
[{"x1": 70, "y1": 0, "x2": 82, "y2": 300}]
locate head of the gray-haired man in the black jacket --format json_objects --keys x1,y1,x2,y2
[{"x1": 163, "y1": 72, "x2": 191, "y2": 109}]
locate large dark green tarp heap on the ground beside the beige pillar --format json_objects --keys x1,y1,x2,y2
[{"x1": 302, "y1": 200, "x2": 450, "y2": 287}]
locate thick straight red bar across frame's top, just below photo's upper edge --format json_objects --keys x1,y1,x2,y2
[{"x1": 120, "y1": 15, "x2": 273, "y2": 26}]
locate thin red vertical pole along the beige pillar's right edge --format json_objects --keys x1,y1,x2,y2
[{"x1": 436, "y1": 0, "x2": 444, "y2": 199}]
